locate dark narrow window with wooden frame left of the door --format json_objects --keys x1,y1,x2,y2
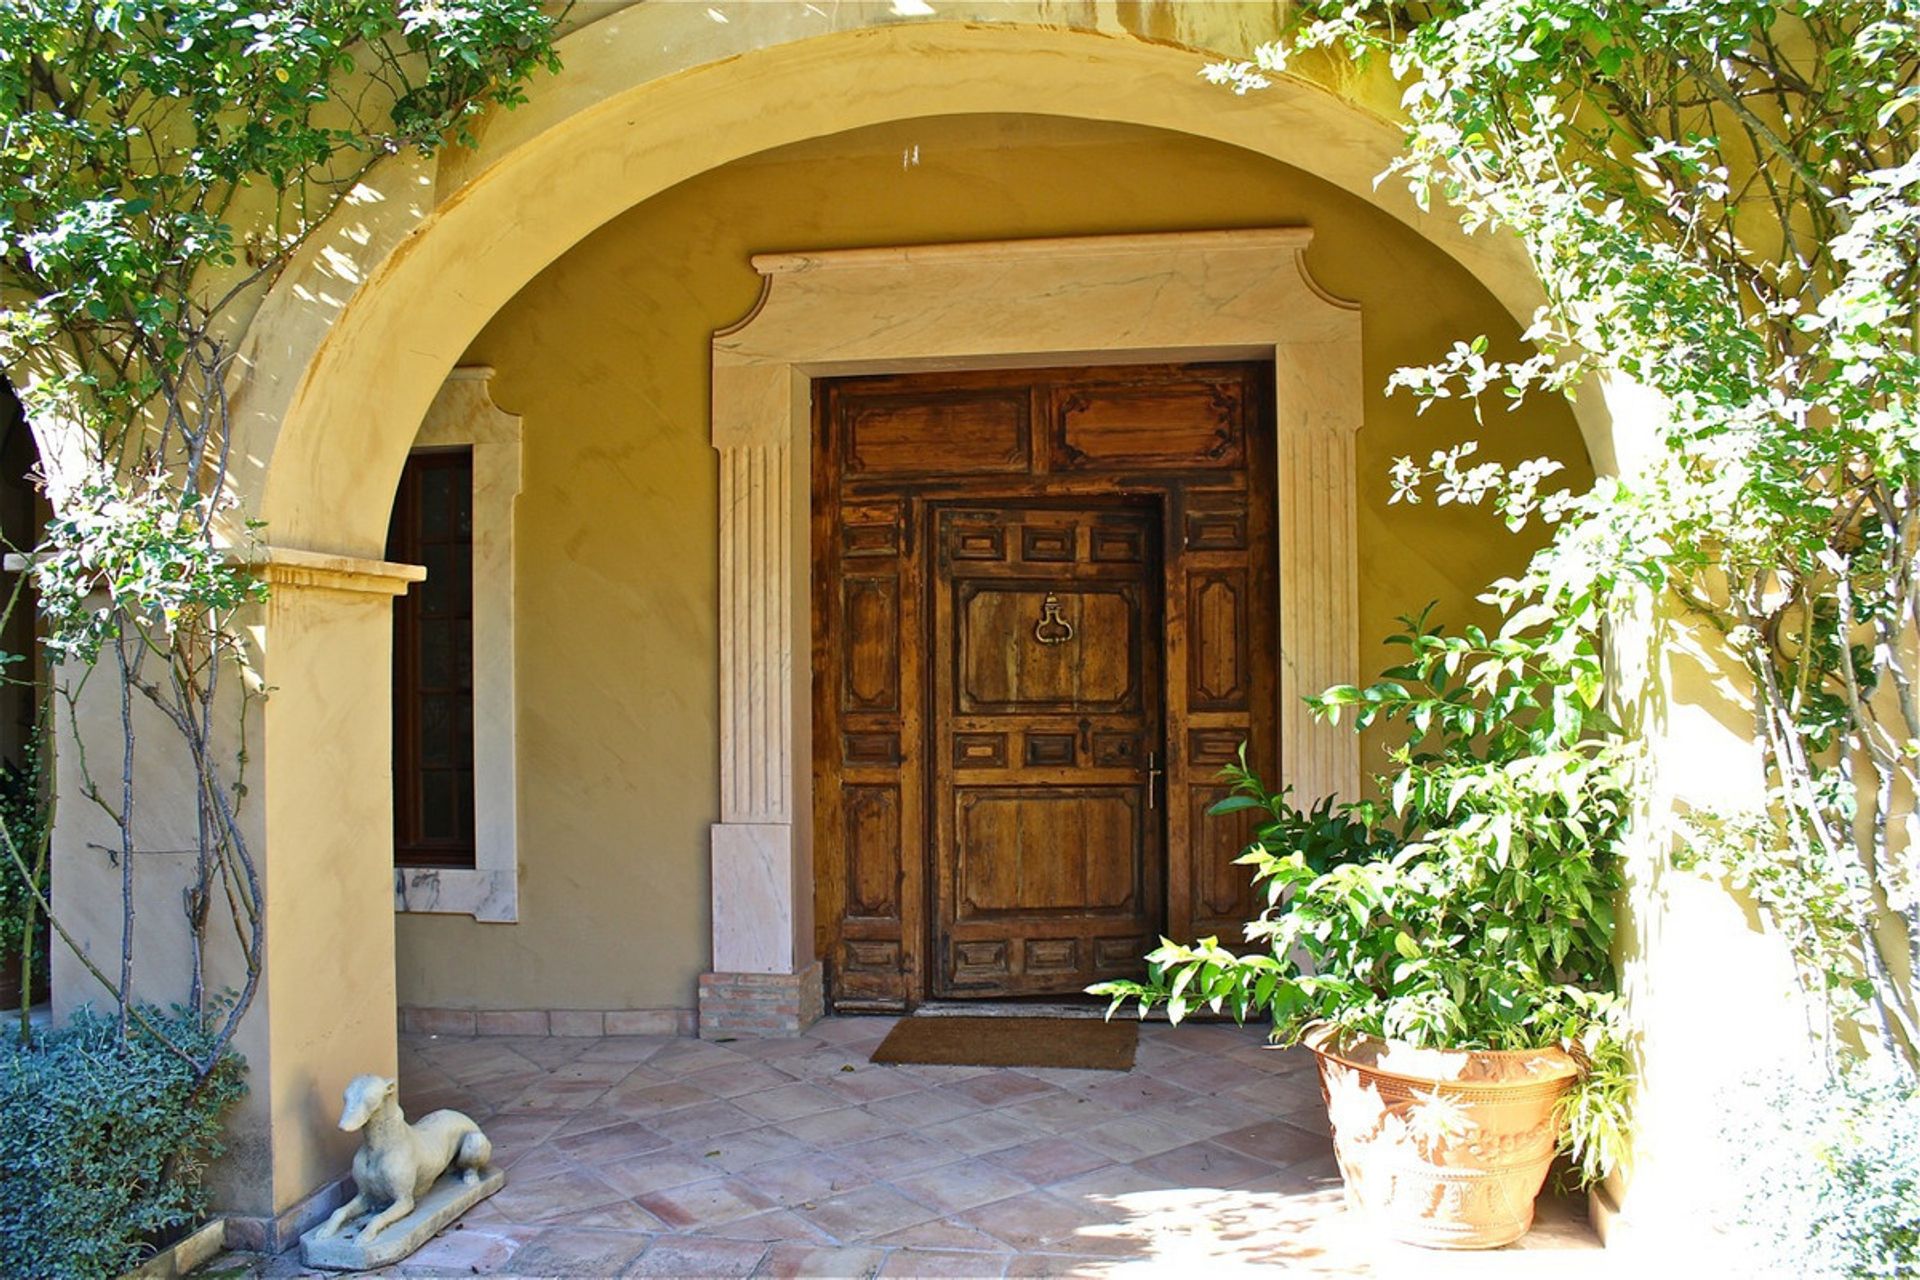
[{"x1": 386, "y1": 449, "x2": 474, "y2": 867}]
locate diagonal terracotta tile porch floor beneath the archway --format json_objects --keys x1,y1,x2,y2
[{"x1": 211, "y1": 1017, "x2": 1601, "y2": 1278}]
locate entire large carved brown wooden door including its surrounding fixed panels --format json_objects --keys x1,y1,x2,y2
[{"x1": 812, "y1": 365, "x2": 1277, "y2": 1009}]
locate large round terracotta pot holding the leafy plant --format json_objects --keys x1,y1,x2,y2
[{"x1": 1306, "y1": 1027, "x2": 1580, "y2": 1249}]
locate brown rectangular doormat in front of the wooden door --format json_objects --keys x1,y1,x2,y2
[{"x1": 874, "y1": 1017, "x2": 1140, "y2": 1071}]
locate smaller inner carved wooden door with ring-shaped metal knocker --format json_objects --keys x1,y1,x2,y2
[{"x1": 929, "y1": 505, "x2": 1165, "y2": 996}]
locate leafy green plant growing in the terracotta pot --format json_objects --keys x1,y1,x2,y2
[{"x1": 1092, "y1": 610, "x2": 1628, "y2": 1180}]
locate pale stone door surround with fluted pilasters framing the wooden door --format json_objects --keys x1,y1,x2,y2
[{"x1": 699, "y1": 226, "x2": 1363, "y2": 1036}]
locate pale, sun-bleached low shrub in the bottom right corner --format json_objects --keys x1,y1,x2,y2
[{"x1": 1724, "y1": 1069, "x2": 1920, "y2": 1278}]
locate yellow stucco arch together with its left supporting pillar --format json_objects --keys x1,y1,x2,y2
[{"x1": 161, "y1": 4, "x2": 1635, "y2": 1238}]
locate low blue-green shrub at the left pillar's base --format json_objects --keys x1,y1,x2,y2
[{"x1": 0, "y1": 1009, "x2": 246, "y2": 1278}]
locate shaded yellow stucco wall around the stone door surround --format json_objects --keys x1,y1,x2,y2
[{"x1": 397, "y1": 115, "x2": 1586, "y2": 1009}]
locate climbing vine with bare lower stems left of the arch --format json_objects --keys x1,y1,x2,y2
[{"x1": 0, "y1": 0, "x2": 559, "y2": 1077}]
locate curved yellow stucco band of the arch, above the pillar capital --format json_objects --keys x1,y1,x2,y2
[{"x1": 236, "y1": 6, "x2": 1613, "y2": 555}]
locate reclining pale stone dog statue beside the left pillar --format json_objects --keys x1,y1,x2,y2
[{"x1": 315, "y1": 1075, "x2": 493, "y2": 1244}]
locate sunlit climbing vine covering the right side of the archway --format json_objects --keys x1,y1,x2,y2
[{"x1": 1208, "y1": 0, "x2": 1920, "y2": 1079}]
